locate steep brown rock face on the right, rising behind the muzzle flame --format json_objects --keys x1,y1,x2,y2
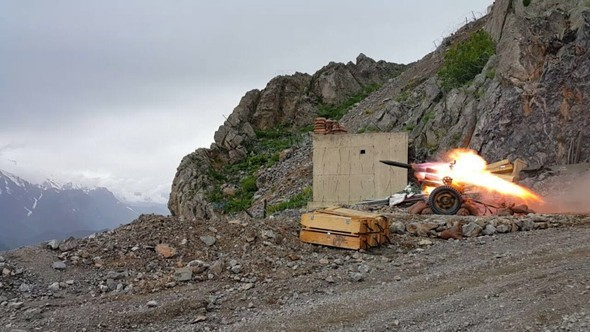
[{"x1": 343, "y1": 0, "x2": 590, "y2": 168}]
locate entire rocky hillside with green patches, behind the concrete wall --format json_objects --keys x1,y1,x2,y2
[{"x1": 169, "y1": 0, "x2": 590, "y2": 223}]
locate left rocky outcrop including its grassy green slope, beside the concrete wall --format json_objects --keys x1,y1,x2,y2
[{"x1": 168, "y1": 54, "x2": 405, "y2": 219}]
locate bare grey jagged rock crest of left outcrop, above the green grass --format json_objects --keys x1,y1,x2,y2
[{"x1": 168, "y1": 54, "x2": 405, "y2": 219}]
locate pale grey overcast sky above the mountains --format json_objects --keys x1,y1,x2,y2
[{"x1": 0, "y1": 0, "x2": 493, "y2": 202}]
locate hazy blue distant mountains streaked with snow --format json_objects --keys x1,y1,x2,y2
[{"x1": 0, "y1": 171, "x2": 169, "y2": 250}]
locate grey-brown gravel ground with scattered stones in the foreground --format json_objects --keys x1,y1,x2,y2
[{"x1": 0, "y1": 216, "x2": 590, "y2": 331}]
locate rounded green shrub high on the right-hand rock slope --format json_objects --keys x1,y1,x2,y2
[{"x1": 438, "y1": 30, "x2": 496, "y2": 91}]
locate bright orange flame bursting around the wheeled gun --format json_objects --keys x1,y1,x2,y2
[{"x1": 416, "y1": 149, "x2": 543, "y2": 202}]
